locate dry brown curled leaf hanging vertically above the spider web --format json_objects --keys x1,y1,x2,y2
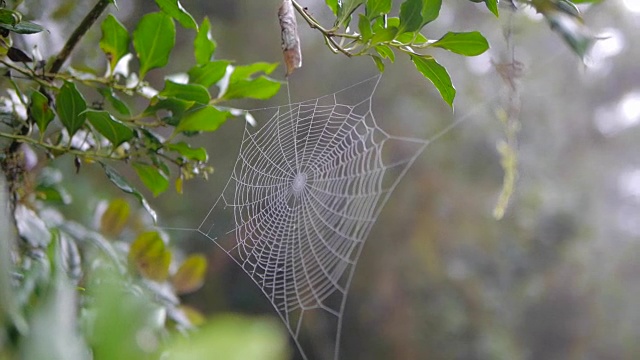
[{"x1": 278, "y1": 0, "x2": 302, "y2": 76}]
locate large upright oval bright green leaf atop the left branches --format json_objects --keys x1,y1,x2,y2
[{"x1": 133, "y1": 13, "x2": 176, "y2": 79}]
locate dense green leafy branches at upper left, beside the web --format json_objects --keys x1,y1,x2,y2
[{"x1": 0, "y1": 0, "x2": 281, "y2": 215}]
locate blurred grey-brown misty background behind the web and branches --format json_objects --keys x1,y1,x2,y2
[{"x1": 20, "y1": 0, "x2": 640, "y2": 359}]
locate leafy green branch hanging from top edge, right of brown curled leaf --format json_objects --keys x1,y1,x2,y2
[{"x1": 292, "y1": 0, "x2": 596, "y2": 107}]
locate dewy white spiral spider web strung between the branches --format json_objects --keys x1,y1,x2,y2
[{"x1": 197, "y1": 76, "x2": 428, "y2": 359}]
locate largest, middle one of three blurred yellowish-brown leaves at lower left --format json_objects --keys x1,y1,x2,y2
[{"x1": 129, "y1": 231, "x2": 171, "y2": 281}]
